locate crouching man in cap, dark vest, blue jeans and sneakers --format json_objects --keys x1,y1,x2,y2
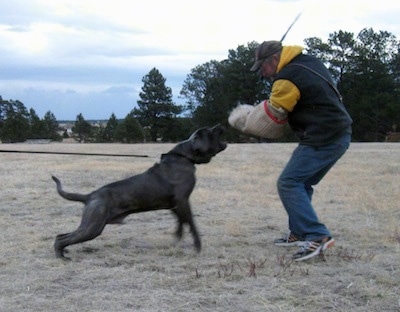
[{"x1": 251, "y1": 41, "x2": 352, "y2": 261}]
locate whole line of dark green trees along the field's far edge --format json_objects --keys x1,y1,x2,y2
[{"x1": 0, "y1": 28, "x2": 400, "y2": 143}]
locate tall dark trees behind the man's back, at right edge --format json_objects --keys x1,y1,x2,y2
[{"x1": 305, "y1": 29, "x2": 400, "y2": 141}]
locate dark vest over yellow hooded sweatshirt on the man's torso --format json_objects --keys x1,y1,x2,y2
[{"x1": 270, "y1": 46, "x2": 352, "y2": 146}]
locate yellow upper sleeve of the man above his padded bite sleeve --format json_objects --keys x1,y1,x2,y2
[{"x1": 269, "y1": 79, "x2": 300, "y2": 112}]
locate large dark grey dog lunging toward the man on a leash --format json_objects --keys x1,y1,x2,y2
[{"x1": 52, "y1": 124, "x2": 227, "y2": 260}]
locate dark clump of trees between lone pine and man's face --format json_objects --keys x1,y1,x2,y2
[{"x1": 180, "y1": 42, "x2": 270, "y2": 140}]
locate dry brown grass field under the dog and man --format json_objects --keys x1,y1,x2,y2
[{"x1": 0, "y1": 143, "x2": 400, "y2": 312}]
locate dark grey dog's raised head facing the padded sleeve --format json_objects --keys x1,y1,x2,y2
[{"x1": 173, "y1": 124, "x2": 227, "y2": 164}]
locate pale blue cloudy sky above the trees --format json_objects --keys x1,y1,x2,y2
[{"x1": 0, "y1": 0, "x2": 400, "y2": 120}]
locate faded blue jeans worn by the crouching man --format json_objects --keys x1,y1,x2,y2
[{"x1": 277, "y1": 135, "x2": 351, "y2": 241}]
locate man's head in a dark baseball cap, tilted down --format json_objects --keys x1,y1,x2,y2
[{"x1": 250, "y1": 40, "x2": 282, "y2": 78}]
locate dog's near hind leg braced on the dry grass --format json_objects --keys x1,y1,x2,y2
[{"x1": 54, "y1": 202, "x2": 107, "y2": 260}]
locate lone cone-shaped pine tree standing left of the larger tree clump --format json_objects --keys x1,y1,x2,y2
[{"x1": 132, "y1": 68, "x2": 182, "y2": 142}]
